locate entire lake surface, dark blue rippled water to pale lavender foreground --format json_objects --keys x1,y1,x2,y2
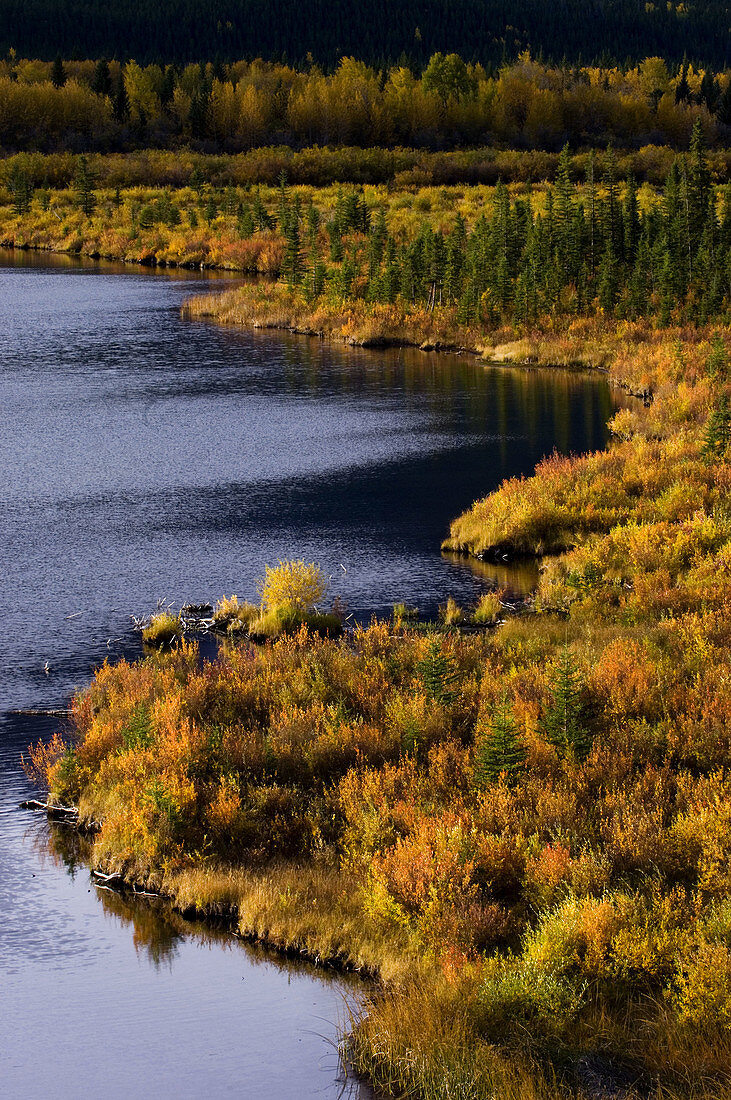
[{"x1": 0, "y1": 254, "x2": 613, "y2": 1100}]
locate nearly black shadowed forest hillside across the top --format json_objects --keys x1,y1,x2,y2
[{"x1": 0, "y1": 0, "x2": 729, "y2": 66}]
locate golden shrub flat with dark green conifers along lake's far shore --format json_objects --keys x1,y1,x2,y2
[{"x1": 5, "y1": 121, "x2": 731, "y2": 331}]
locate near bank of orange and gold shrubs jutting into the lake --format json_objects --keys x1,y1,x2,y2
[{"x1": 29, "y1": 326, "x2": 731, "y2": 1098}]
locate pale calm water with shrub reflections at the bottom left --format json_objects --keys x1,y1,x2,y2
[{"x1": 0, "y1": 792, "x2": 372, "y2": 1100}]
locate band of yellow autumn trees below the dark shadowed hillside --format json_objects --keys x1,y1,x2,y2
[{"x1": 0, "y1": 53, "x2": 731, "y2": 153}]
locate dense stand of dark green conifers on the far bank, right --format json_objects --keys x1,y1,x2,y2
[{"x1": 269, "y1": 123, "x2": 731, "y2": 327}]
